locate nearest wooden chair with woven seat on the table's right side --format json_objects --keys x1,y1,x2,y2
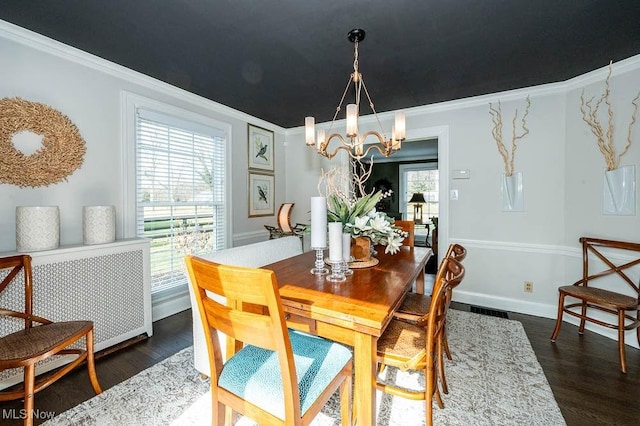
[{"x1": 376, "y1": 257, "x2": 464, "y2": 425}]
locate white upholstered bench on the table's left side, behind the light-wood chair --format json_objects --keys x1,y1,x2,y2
[{"x1": 189, "y1": 237, "x2": 302, "y2": 376}]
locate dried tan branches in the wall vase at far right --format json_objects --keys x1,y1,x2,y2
[{"x1": 580, "y1": 62, "x2": 640, "y2": 170}]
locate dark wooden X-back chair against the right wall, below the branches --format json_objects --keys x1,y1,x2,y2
[{"x1": 551, "y1": 237, "x2": 640, "y2": 373}]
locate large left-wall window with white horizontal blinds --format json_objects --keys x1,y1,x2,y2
[{"x1": 136, "y1": 109, "x2": 227, "y2": 294}]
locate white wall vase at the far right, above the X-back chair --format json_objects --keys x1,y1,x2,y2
[{"x1": 602, "y1": 165, "x2": 636, "y2": 216}]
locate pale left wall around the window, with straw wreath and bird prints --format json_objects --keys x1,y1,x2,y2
[{"x1": 0, "y1": 21, "x2": 285, "y2": 252}]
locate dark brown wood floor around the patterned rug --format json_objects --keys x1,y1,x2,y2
[{"x1": 0, "y1": 304, "x2": 640, "y2": 426}]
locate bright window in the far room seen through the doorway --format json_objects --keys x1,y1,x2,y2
[{"x1": 400, "y1": 163, "x2": 440, "y2": 223}]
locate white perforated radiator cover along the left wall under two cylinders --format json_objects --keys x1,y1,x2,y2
[{"x1": 0, "y1": 238, "x2": 153, "y2": 389}]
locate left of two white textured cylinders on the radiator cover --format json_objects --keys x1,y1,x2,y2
[{"x1": 16, "y1": 206, "x2": 60, "y2": 253}]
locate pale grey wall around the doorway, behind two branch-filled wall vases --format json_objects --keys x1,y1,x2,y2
[{"x1": 287, "y1": 56, "x2": 640, "y2": 345}]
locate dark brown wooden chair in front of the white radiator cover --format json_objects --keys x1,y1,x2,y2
[{"x1": 0, "y1": 254, "x2": 102, "y2": 425}]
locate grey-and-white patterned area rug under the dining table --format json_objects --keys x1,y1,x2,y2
[{"x1": 46, "y1": 310, "x2": 565, "y2": 426}]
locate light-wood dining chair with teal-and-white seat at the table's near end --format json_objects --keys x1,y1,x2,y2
[{"x1": 186, "y1": 255, "x2": 353, "y2": 425}]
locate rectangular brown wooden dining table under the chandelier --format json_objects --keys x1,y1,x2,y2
[{"x1": 263, "y1": 246, "x2": 432, "y2": 426}]
